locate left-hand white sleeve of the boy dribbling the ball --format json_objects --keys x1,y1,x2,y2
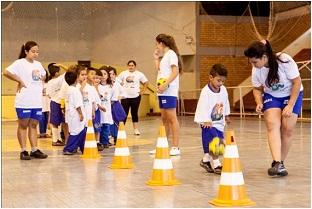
[{"x1": 194, "y1": 88, "x2": 211, "y2": 123}]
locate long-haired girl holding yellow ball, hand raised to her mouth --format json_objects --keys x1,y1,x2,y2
[{"x1": 151, "y1": 34, "x2": 182, "y2": 155}]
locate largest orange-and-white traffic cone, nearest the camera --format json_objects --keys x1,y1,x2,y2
[{"x1": 209, "y1": 130, "x2": 255, "y2": 207}]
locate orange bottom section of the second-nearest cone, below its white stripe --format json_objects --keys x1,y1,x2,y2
[{"x1": 146, "y1": 169, "x2": 181, "y2": 186}]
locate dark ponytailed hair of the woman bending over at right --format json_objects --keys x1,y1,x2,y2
[{"x1": 244, "y1": 40, "x2": 288, "y2": 87}]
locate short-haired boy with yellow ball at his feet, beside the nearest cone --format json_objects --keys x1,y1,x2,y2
[{"x1": 194, "y1": 64, "x2": 230, "y2": 175}]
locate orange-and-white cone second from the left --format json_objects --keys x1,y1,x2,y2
[{"x1": 110, "y1": 122, "x2": 134, "y2": 169}]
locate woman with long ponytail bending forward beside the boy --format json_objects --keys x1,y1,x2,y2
[{"x1": 244, "y1": 40, "x2": 303, "y2": 176}]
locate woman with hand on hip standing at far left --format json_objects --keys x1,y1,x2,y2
[{"x1": 3, "y1": 41, "x2": 48, "y2": 160}]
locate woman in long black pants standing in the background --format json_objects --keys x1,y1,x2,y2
[{"x1": 117, "y1": 60, "x2": 148, "y2": 135}]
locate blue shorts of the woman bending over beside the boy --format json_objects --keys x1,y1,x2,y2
[{"x1": 262, "y1": 91, "x2": 303, "y2": 115}]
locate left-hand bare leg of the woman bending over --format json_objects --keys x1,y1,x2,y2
[{"x1": 264, "y1": 108, "x2": 282, "y2": 161}]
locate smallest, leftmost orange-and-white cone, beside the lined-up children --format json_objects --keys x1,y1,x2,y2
[{"x1": 81, "y1": 120, "x2": 100, "y2": 159}]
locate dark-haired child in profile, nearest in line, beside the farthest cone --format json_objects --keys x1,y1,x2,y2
[{"x1": 63, "y1": 66, "x2": 87, "y2": 155}]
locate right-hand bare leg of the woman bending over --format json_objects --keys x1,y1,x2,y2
[{"x1": 281, "y1": 113, "x2": 298, "y2": 161}]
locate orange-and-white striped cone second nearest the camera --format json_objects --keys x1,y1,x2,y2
[{"x1": 146, "y1": 126, "x2": 180, "y2": 186}]
